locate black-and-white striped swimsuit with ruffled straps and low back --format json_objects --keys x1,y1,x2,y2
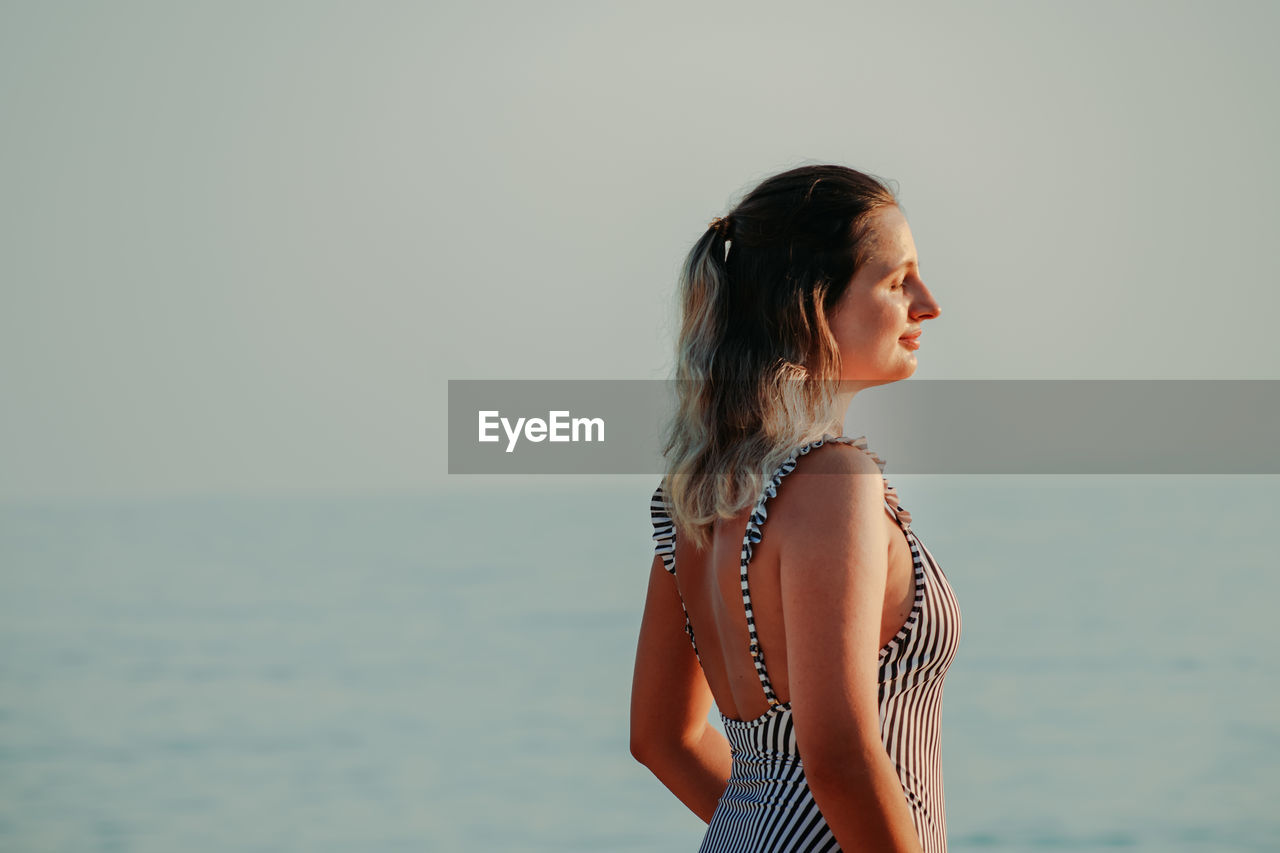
[{"x1": 650, "y1": 435, "x2": 960, "y2": 853}]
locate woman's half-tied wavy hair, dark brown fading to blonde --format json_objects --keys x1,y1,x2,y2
[{"x1": 663, "y1": 165, "x2": 897, "y2": 548}]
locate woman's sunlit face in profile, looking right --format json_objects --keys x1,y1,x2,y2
[{"x1": 828, "y1": 206, "x2": 941, "y2": 387}]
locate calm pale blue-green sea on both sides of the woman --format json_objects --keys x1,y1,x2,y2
[{"x1": 0, "y1": 476, "x2": 1280, "y2": 853}]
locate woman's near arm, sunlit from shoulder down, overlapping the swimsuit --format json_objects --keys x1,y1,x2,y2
[{"x1": 781, "y1": 448, "x2": 920, "y2": 853}]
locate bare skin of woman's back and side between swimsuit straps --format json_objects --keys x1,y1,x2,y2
[{"x1": 673, "y1": 444, "x2": 916, "y2": 720}]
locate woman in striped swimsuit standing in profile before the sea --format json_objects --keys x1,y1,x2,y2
[{"x1": 631, "y1": 165, "x2": 960, "y2": 853}]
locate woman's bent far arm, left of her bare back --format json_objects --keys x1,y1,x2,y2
[{"x1": 631, "y1": 556, "x2": 731, "y2": 824}]
